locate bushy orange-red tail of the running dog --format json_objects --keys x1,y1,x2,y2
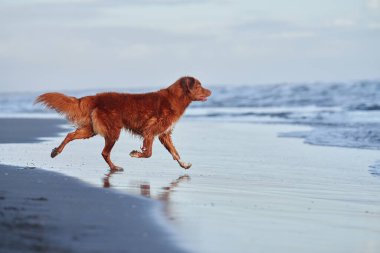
[{"x1": 34, "y1": 92, "x2": 87, "y2": 125}]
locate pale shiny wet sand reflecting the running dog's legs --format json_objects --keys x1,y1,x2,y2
[{"x1": 0, "y1": 119, "x2": 380, "y2": 253}]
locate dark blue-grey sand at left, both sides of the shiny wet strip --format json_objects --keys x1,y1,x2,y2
[{"x1": 0, "y1": 119, "x2": 188, "y2": 253}]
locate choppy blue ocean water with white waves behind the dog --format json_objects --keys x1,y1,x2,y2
[{"x1": 0, "y1": 80, "x2": 380, "y2": 149}]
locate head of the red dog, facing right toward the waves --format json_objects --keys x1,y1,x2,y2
[{"x1": 178, "y1": 76, "x2": 211, "y2": 102}]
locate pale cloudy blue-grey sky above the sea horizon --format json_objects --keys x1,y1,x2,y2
[{"x1": 0, "y1": 0, "x2": 380, "y2": 92}]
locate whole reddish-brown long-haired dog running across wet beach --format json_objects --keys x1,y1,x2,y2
[{"x1": 36, "y1": 77, "x2": 211, "y2": 171}]
